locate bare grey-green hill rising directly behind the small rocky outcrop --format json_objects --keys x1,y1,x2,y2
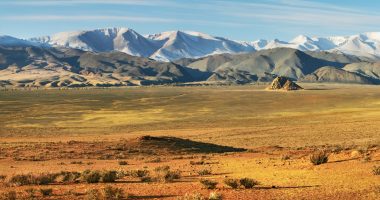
[{"x1": 186, "y1": 48, "x2": 361, "y2": 80}]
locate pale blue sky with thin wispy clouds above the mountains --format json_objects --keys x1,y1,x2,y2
[{"x1": 0, "y1": 0, "x2": 380, "y2": 41}]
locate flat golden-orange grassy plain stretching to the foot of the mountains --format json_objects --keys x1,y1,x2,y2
[{"x1": 0, "y1": 84, "x2": 380, "y2": 199}]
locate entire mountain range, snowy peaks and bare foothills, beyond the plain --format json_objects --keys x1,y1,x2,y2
[{"x1": 0, "y1": 28, "x2": 380, "y2": 87}]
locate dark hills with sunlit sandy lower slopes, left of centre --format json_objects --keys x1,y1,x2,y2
[{"x1": 0, "y1": 47, "x2": 202, "y2": 87}]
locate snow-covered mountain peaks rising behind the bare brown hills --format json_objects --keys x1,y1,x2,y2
[{"x1": 29, "y1": 28, "x2": 380, "y2": 61}]
